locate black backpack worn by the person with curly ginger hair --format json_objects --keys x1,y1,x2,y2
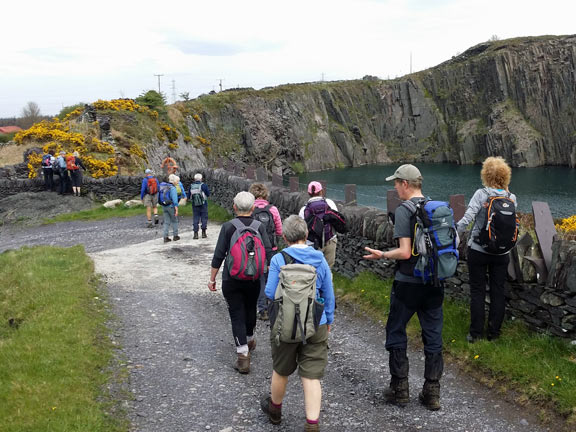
[{"x1": 474, "y1": 191, "x2": 520, "y2": 254}]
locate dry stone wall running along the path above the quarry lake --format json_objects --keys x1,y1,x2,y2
[{"x1": 0, "y1": 169, "x2": 576, "y2": 339}]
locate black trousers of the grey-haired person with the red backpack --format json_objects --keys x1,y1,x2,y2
[{"x1": 222, "y1": 279, "x2": 260, "y2": 347}]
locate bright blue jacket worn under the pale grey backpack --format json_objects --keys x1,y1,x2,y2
[{"x1": 265, "y1": 245, "x2": 335, "y2": 324}]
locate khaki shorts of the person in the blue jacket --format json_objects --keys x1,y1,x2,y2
[{"x1": 270, "y1": 324, "x2": 328, "y2": 379}]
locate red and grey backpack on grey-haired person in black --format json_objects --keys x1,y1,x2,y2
[{"x1": 226, "y1": 219, "x2": 266, "y2": 281}]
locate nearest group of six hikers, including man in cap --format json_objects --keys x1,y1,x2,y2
[{"x1": 198, "y1": 157, "x2": 518, "y2": 431}]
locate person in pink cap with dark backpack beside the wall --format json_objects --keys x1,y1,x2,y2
[{"x1": 298, "y1": 181, "x2": 338, "y2": 268}]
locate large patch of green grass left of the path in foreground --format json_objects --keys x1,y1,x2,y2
[{"x1": 0, "y1": 246, "x2": 127, "y2": 432}]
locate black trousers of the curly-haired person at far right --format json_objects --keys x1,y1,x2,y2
[{"x1": 468, "y1": 248, "x2": 510, "y2": 338}]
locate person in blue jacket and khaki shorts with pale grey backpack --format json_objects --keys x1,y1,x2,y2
[{"x1": 260, "y1": 215, "x2": 334, "y2": 431}]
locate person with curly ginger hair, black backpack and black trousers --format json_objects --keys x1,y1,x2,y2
[{"x1": 457, "y1": 157, "x2": 517, "y2": 343}]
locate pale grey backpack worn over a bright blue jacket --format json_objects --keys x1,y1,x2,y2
[{"x1": 270, "y1": 251, "x2": 324, "y2": 345}]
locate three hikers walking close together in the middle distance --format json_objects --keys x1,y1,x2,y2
[{"x1": 140, "y1": 169, "x2": 210, "y2": 243}]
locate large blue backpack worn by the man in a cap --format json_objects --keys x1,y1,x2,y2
[{"x1": 401, "y1": 199, "x2": 460, "y2": 286}]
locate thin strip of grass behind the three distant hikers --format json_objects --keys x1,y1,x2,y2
[{"x1": 43, "y1": 200, "x2": 232, "y2": 224}]
